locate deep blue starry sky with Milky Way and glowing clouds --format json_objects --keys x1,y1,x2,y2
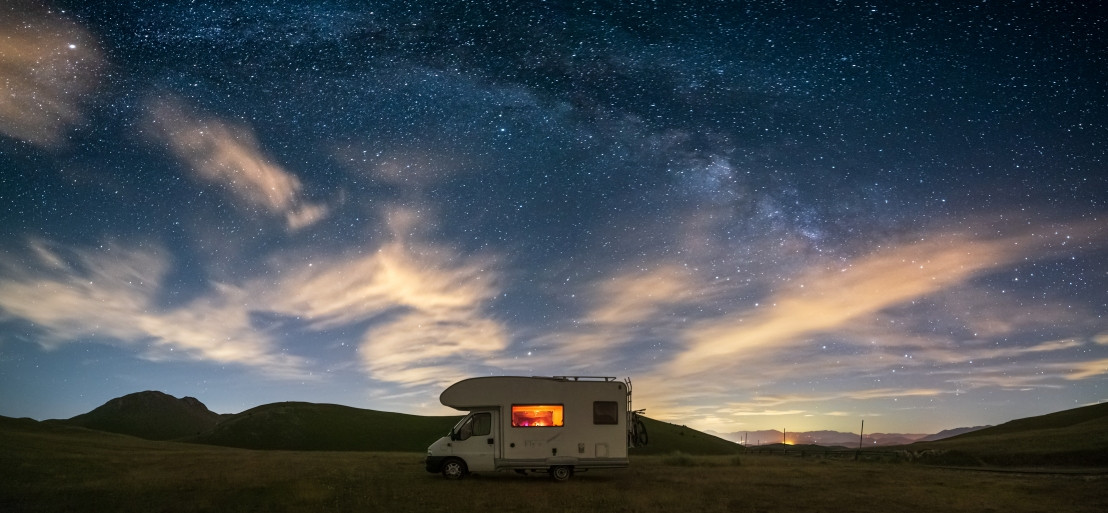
[{"x1": 0, "y1": 0, "x2": 1108, "y2": 433}]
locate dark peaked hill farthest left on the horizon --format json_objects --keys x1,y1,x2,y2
[{"x1": 53, "y1": 390, "x2": 220, "y2": 440}]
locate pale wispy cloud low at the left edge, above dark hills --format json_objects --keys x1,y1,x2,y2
[{"x1": 0, "y1": 240, "x2": 301, "y2": 377}]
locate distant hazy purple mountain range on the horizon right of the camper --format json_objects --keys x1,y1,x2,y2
[{"x1": 709, "y1": 425, "x2": 988, "y2": 448}]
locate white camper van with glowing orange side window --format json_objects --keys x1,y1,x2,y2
[{"x1": 427, "y1": 376, "x2": 647, "y2": 481}]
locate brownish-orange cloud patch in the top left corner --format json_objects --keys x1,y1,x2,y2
[{"x1": 0, "y1": 9, "x2": 104, "y2": 146}]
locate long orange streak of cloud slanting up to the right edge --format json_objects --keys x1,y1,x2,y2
[{"x1": 666, "y1": 224, "x2": 1102, "y2": 376}]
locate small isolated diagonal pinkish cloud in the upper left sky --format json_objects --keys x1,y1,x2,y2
[{"x1": 147, "y1": 100, "x2": 328, "y2": 230}]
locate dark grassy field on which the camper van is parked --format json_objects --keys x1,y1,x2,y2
[{"x1": 0, "y1": 418, "x2": 1108, "y2": 513}]
